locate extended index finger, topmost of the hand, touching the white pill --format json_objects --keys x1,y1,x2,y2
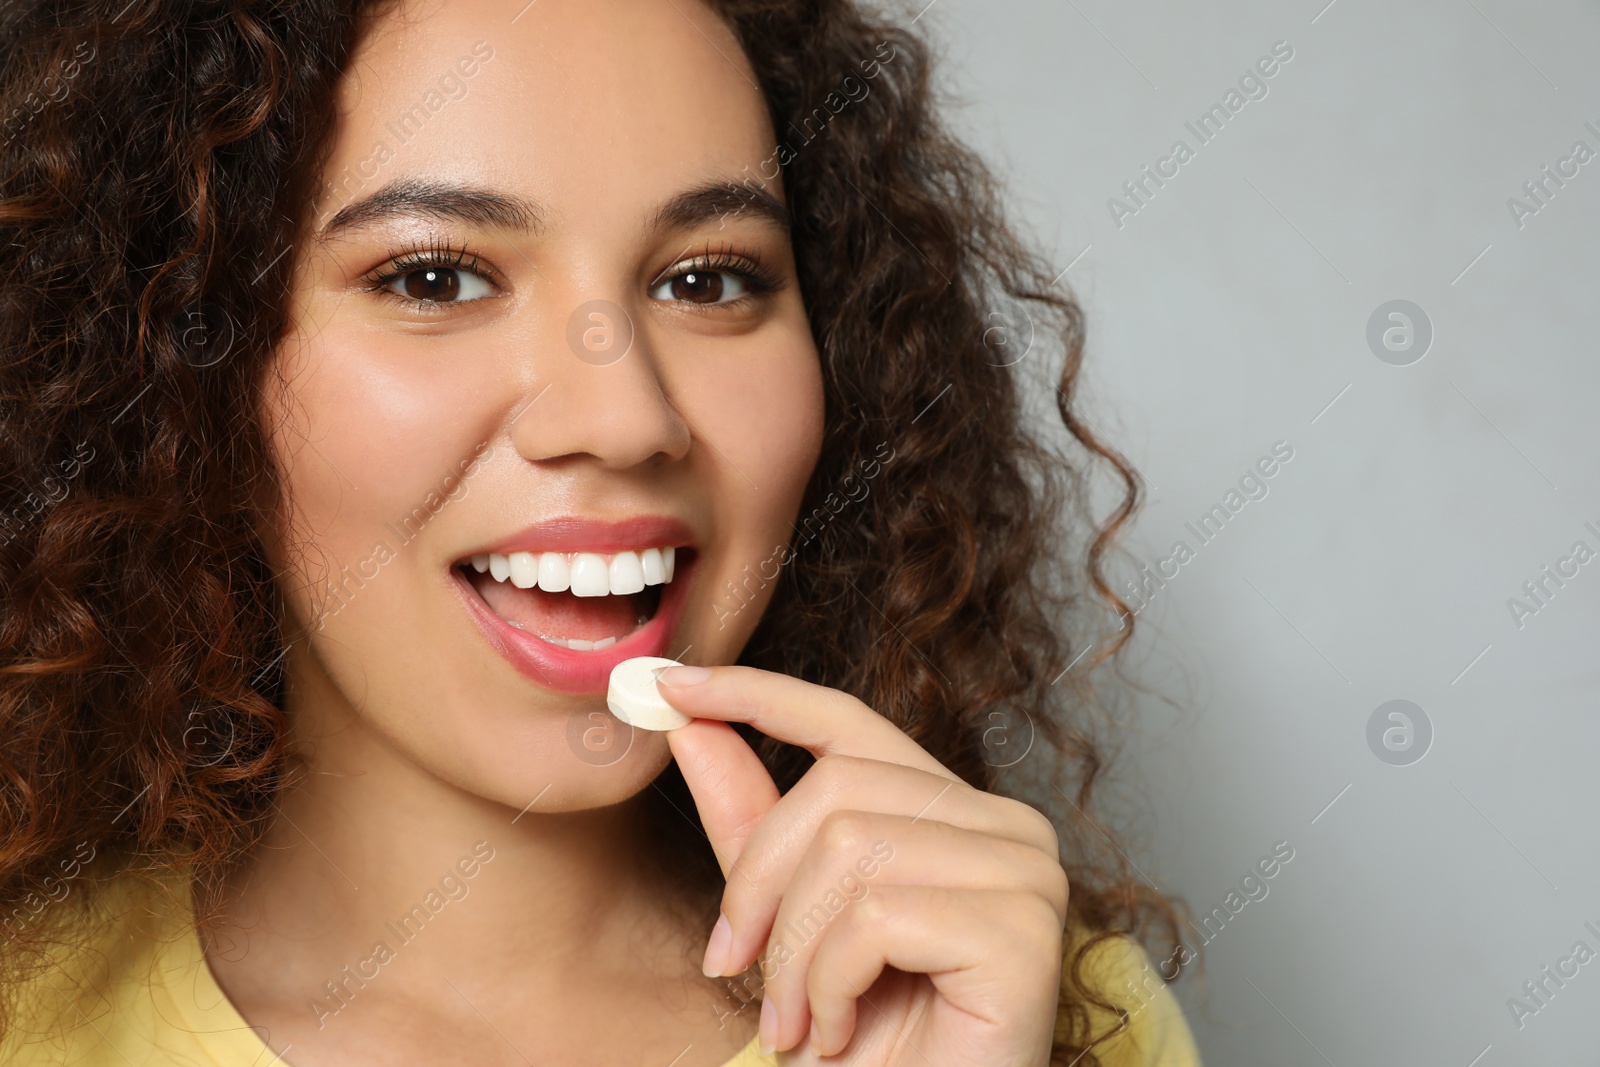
[{"x1": 656, "y1": 667, "x2": 960, "y2": 781}]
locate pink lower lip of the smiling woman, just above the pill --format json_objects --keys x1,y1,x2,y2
[{"x1": 450, "y1": 558, "x2": 698, "y2": 693}]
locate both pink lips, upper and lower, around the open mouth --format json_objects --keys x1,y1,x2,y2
[{"x1": 450, "y1": 517, "x2": 699, "y2": 693}]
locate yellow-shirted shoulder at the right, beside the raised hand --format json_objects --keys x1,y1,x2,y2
[{"x1": 1056, "y1": 933, "x2": 1200, "y2": 1067}]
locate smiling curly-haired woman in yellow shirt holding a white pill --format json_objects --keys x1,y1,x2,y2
[{"x1": 0, "y1": 0, "x2": 1197, "y2": 1067}]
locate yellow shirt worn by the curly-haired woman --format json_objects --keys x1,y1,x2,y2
[{"x1": 0, "y1": 875, "x2": 1200, "y2": 1067}]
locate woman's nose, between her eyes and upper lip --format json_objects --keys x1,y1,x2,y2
[{"x1": 512, "y1": 299, "x2": 690, "y2": 470}]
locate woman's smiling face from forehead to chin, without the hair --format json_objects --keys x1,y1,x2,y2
[{"x1": 266, "y1": 0, "x2": 822, "y2": 811}]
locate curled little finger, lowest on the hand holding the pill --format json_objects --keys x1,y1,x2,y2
[{"x1": 800, "y1": 886, "x2": 1061, "y2": 1062}]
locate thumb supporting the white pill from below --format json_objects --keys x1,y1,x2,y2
[{"x1": 667, "y1": 718, "x2": 778, "y2": 878}]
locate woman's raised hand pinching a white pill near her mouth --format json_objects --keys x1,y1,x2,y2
[{"x1": 658, "y1": 667, "x2": 1067, "y2": 1067}]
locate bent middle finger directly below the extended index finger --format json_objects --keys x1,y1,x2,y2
[{"x1": 713, "y1": 758, "x2": 1061, "y2": 974}]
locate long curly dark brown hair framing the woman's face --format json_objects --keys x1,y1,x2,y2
[{"x1": 0, "y1": 0, "x2": 1179, "y2": 1064}]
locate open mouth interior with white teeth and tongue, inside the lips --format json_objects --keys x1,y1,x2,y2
[{"x1": 454, "y1": 545, "x2": 694, "y2": 653}]
